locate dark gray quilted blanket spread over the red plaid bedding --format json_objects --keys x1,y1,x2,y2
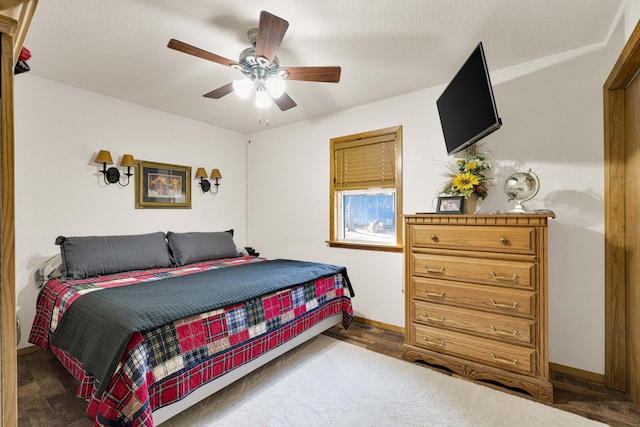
[{"x1": 52, "y1": 260, "x2": 353, "y2": 395}]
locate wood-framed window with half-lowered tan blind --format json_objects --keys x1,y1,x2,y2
[{"x1": 329, "y1": 126, "x2": 402, "y2": 251}]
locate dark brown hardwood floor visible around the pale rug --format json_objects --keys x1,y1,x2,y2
[{"x1": 18, "y1": 322, "x2": 640, "y2": 427}]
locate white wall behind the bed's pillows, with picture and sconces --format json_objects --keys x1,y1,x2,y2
[{"x1": 15, "y1": 73, "x2": 247, "y2": 347}]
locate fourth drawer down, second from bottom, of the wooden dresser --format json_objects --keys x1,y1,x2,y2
[{"x1": 411, "y1": 300, "x2": 536, "y2": 345}]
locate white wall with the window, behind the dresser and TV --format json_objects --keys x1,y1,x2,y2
[{"x1": 248, "y1": 21, "x2": 624, "y2": 373}]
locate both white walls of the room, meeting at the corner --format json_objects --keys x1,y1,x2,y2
[{"x1": 16, "y1": 10, "x2": 635, "y2": 373}]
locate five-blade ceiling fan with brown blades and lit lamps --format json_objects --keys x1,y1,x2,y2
[{"x1": 167, "y1": 11, "x2": 341, "y2": 111}]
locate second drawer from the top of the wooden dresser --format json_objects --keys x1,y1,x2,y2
[{"x1": 411, "y1": 253, "x2": 536, "y2": 289}]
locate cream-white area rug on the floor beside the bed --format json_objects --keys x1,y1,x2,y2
[{"x1": 161, "y1": 335, "x2": 605, "y2": 427}]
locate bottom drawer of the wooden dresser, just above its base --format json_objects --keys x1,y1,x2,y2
[{"x1": 413, "y1": 324, "x2": 536, "y2": 375}]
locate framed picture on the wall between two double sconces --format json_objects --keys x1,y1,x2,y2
[{"x1": 135, "y1": 160, "x2": 191, "y2": 209}]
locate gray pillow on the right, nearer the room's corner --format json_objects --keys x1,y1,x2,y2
[{"x1": 167, "y1": 231, "x2": 240, "y2": 265}]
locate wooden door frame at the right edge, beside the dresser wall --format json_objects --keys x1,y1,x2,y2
[{"x1": 603, "y1": 21, "x2": 640, "y2": 391}]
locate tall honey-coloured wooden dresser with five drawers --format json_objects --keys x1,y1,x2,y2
[{"x1": 402, "y1": 214, "x2": 553, "y2": 402}]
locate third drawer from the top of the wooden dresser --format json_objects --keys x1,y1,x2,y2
[{"x1": 410, "y1": 277, "x2": 536, "y2": 319}]
